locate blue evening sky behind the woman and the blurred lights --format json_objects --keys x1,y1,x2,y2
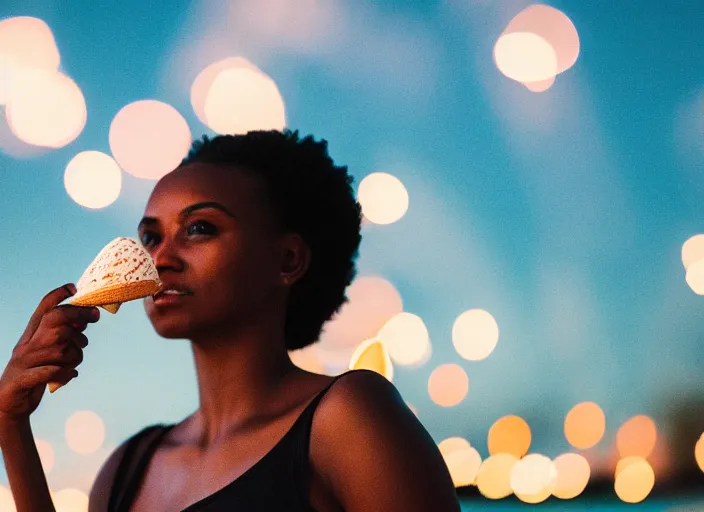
[{"x1": 0, "y1": 0, "x2": 704, "y2": 488}]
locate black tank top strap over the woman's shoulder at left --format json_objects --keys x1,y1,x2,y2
[{"x1": 108, "y1": 424, "x2": 177, "y2": 512}]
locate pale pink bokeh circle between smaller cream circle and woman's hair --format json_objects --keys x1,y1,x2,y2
[{"x1": 109, "y1": 100, "x2": 191, "y2": 180}]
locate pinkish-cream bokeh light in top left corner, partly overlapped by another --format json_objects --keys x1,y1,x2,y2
[{"x1": 0, "y1": 16, "x2": 61, "y2": 105}]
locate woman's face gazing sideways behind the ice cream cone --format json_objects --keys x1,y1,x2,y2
[{"x1": 138, "y1": 163, "x2": 285, "y2": 338}]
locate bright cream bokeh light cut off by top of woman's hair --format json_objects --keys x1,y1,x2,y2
[{"x1": 203, "y1": 67, "x2": 286, "y2": 135}]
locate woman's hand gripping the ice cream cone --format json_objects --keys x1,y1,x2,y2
[{"x1": 0, "y1": 284, "x2": 100, "y2": 421}]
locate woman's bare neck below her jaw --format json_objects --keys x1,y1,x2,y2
[{"x1": 191, "y1": 319, "x2": 297, "y2": 446}]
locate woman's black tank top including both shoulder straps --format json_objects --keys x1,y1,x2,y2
[{"x1": 108, "y1": 370, "x2": 358, "y2": 512}]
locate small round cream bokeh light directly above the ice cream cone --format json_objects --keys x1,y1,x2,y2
[{"x1": 64, "y1": 151, "x2": 122, "y2": 209}]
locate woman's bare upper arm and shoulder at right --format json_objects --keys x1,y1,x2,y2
[{"x1": 311, "y1": 371, "x2": 460, "y2": 512}]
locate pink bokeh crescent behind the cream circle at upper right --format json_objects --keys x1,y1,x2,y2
[{"x1": 504, "y1": 4, "x2": 580, "y2": 73}]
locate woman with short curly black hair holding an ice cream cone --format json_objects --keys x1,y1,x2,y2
[{"x1": 0, "y1": 131, "x2": 459, "y2": 512}]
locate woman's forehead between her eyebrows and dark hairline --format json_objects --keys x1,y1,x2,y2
[{"x1": 145, "y1": 163, "x2": 266, "y2": 217}]
